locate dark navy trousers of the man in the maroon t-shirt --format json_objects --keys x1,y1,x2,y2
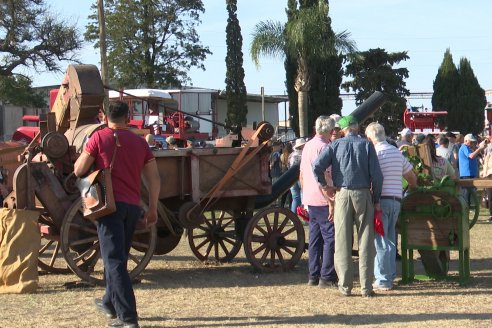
[{"x1": 96, "y1": 202, "x2": 140, "y2": 321}]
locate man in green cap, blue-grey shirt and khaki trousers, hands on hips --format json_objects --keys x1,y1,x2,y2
[{"x1": 313, "y1": 116, "x2": 383, "y2": 297}]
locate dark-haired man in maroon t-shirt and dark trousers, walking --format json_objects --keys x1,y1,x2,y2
[{"x1": 74, "y1": 101, "x2": 160, "y2": 327}]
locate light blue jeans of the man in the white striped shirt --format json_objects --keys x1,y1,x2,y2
[{"x1": 374, "y1": 199, "x2": 401, "y2": 288}]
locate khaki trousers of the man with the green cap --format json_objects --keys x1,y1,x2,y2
[{"x1": 335, "y1": 188, "x2": 376, "y2": 294}]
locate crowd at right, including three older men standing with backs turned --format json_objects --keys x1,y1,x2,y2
[{"x1": 271, "y1": 115, "x2": 492, "y2": 297}]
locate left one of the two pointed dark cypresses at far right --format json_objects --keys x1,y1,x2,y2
[{"x1": 432, "y1": 49, "x2": 462, "y2": 131}]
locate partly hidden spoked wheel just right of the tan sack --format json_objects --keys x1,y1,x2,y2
[{"x1": 38, "y1": 215, "x2": 71, "y2": 274}]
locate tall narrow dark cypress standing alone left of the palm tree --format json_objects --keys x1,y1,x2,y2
[{"x1": 225, "y1": 0, "x2": 248, "y2": 126}]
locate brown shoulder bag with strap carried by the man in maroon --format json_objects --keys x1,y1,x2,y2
[{"x1": 76, "y1": 132, "x2": 120, "y2": 220}]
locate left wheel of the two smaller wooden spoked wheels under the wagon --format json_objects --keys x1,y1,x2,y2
[{"x1": 188, "y1": 210, "x2": 242, "y2": 263}]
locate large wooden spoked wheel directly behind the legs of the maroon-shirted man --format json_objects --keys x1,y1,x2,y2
[{"x1": 60, "y1": 199, "x2": 156, "y2": 285}]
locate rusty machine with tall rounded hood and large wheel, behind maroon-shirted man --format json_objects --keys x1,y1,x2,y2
[{"x1": 4, "y1": 65, "x2": 156, "y2": 282}]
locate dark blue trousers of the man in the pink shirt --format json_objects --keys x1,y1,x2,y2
[{"x1": 308, "y1": 206, "x2": 338, "y2": 281}]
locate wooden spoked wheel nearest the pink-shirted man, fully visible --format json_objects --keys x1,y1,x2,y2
[{"x1": 243, "y1": 208, "x2": 305, "y2": 272}]
